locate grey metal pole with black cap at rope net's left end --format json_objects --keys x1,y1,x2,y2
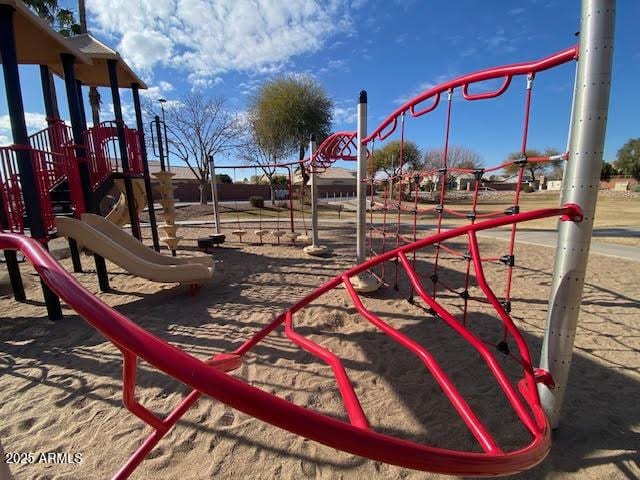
[{"x1": 356, "y1": 90, "x2": 367, "y2": 263}]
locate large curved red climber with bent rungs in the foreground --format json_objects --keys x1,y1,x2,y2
[{"x1": 0, "y1": 204, "x2": 582, "y2": 478}]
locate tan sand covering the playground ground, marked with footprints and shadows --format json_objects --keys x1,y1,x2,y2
[{"x1": 0, "y1": 225, "x2": 640, "y2": 480}]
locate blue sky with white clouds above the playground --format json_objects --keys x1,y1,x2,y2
[{"x1": 0, "y1": 0, "x2": 640, "y2": 171}]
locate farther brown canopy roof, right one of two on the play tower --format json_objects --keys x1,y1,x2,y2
[{"x1": 52, "y1": 33, "x2": 147, "y2": 89}]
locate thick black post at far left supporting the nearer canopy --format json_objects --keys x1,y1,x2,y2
[{"x1": 0, "y1": 5, "x2": 62, "y2": 320}]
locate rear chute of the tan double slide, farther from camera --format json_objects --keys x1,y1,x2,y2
[{"x1": 82, "y1": 213, "x2": 214, "y2": 268}]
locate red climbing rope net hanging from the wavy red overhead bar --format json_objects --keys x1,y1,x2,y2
[{"x1": 364, "y1": 49, "x2": 575, "y2": 330}]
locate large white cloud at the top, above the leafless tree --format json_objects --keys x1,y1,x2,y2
[{"x1": 87, "y1": 0, "x2": 363, "y2": 85}]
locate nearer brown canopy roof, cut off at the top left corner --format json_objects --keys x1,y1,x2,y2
[{"x1": 0, "y1": 0, "x2": 91, "y2": 66}]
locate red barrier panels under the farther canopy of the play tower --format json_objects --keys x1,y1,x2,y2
[{"x1": 83, "y1": 121, "x2": 143, "y2": 190}]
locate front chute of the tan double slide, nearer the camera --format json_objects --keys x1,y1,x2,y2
[{"x1": 56, "y1": 217, "x2": 213, "y2": 283}]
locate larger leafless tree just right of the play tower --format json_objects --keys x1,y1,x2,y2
[{"x1": 145, "y1": 92, "x2": 244, "y2": 205}]
